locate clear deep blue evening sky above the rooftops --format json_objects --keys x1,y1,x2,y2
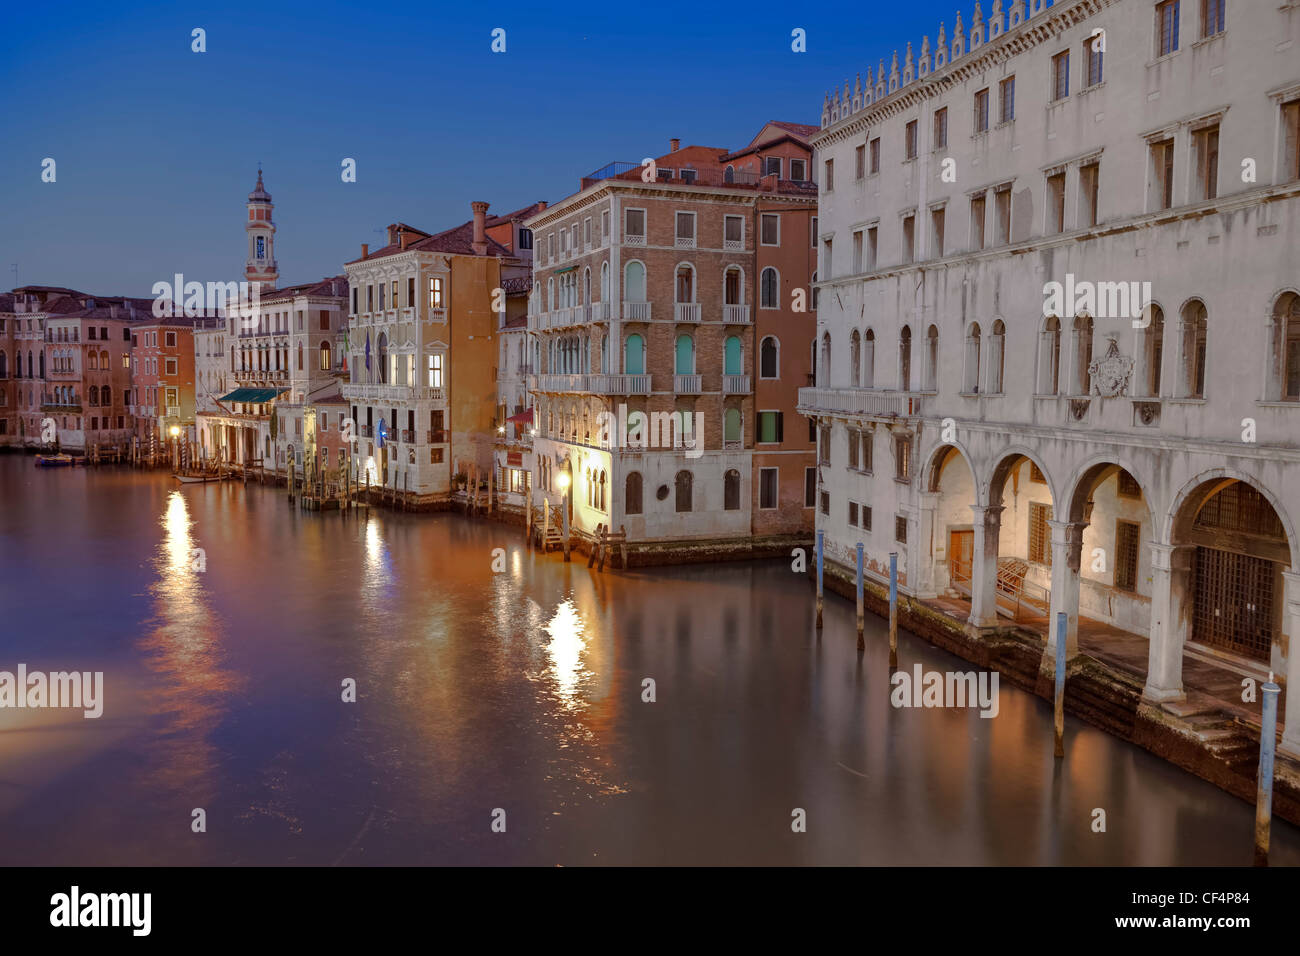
[{"x1": 0, "y1": 0, "x2": 974, "y2": 295}]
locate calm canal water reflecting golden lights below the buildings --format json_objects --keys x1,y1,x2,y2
[{"x1": 0, "y1": 455, "x2": 1300, "y2": 865}]
